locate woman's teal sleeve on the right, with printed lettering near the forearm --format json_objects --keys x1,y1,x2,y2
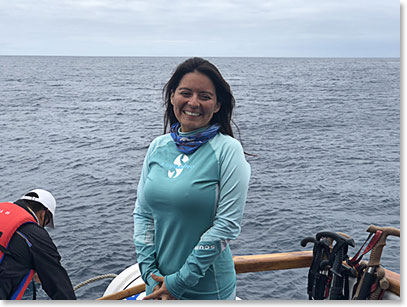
[{"x1": 165, "y1": 139, "x2": 250, "y2": 298}]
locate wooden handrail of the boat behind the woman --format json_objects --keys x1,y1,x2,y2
[{"x1": 98, "y1": 251, "x2": 400, "y2": 300}]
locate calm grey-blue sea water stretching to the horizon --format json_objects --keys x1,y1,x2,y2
[{"x1": 0, "y1": 57, "x2": 400, "y2": 300}]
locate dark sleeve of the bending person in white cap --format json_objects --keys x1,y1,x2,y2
[{"x1": 27, "y1": 225, "x2": 76, "y2": 300}]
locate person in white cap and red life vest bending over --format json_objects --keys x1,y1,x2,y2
[{"x1": 0, "y1": 189, "x2": 76, "y2": 300}]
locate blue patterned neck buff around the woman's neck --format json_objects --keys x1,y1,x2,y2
[{"x1": 171, "y1": 123, "x2": 219, "y2": 154}]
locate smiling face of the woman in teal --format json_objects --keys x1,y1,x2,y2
[{"x1": 171, "y1": 71, "x2": 220, "y2": 132}]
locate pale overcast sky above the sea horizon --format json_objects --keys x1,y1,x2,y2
[{"x1": 0, "y1": 0, "x2": 400, "y2": 57}]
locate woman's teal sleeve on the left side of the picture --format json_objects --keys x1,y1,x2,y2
[{"x1": 133, "y1": 143, "x2": 162, "y2": 293}]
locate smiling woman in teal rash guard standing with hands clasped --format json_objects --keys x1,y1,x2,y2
[{"x1": 134, "y1": 58, "x2": 250, "y2": 300}]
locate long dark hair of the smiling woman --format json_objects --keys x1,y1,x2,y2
[{"x1": 163, "y1": 57, "x2": 239, "y2": 137}]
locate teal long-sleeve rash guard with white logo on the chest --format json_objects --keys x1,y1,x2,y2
[{"x1": 134, "y1": 131, "x2": 250, "y2": 300}]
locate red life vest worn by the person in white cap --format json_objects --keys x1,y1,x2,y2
[{"x1": 0, "y1": 202, "x2": 37, "y2": 300}]
